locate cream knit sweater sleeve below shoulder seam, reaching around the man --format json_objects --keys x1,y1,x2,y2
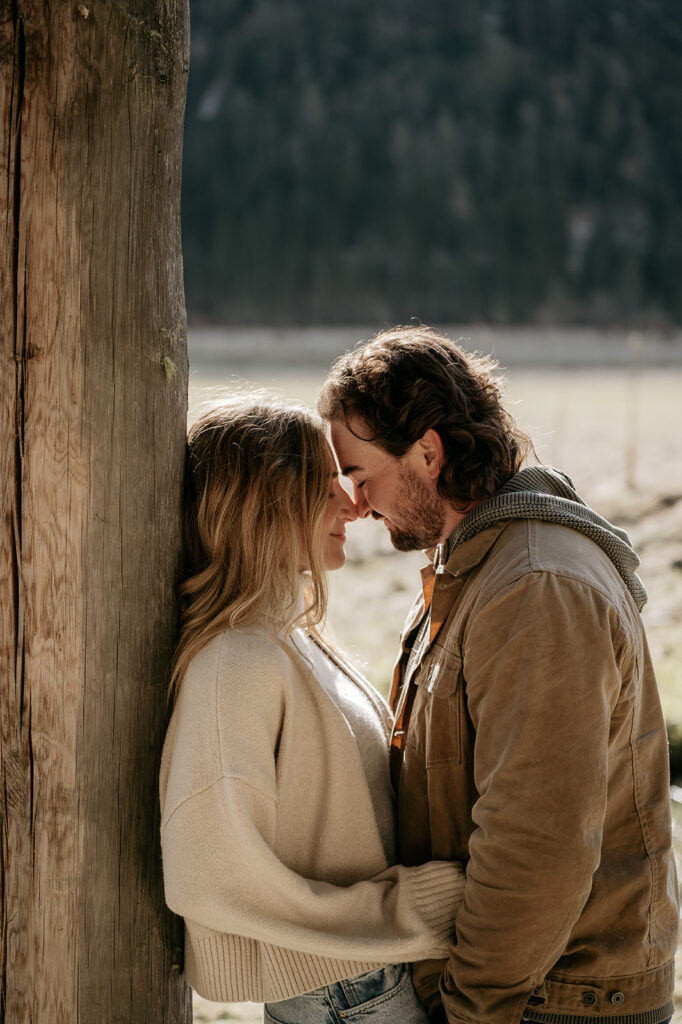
[{"x1": 162, "y1": 776, "x2": 464, "y2": 964}]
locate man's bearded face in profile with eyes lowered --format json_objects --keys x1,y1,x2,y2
[{"x1": 331, "y1": 418, "x2": 450, "y2": 551}]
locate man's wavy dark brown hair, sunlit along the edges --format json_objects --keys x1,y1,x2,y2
[{"x1": 317, "y1": 327, "x2": 532, "y2": 507}]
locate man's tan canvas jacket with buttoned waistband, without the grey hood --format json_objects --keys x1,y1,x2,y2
[{"x1": 392, "y1": 520, "x2": 678, "y2": 1024}]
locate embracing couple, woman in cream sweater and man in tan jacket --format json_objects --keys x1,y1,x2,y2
[{"x1": 161, "y1": 327, "x2": 678, "y2": 1024}]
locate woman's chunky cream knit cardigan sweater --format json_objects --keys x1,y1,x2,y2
[{"x1": 161, "y1": 624, "x2": 464, "y2": 1001}]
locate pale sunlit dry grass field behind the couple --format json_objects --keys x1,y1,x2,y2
[{"x1": 189, "y1": 333, "x2": 682, "y2": 1024}]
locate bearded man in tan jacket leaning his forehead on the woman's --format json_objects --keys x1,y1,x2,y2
[{"x1": 319, "y1": 327, "x2": 678, "y2": 1024}]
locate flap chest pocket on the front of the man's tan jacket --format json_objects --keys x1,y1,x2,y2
[{"x1": 406, "y1": 643, "x2": 464, "y2": 768}]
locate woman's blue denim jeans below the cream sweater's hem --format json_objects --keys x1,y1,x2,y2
[{"x1": 263, "y1": 964, "x2": 428, "y2": 1024}]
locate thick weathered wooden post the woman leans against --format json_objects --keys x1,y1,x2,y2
[{"x1": 0, "y1": 0, "x2": 191, "y2": 1024}]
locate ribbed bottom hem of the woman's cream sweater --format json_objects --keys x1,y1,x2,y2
[{"x1": 184, "y1": 929, "x2": 386, "y2": 1002}]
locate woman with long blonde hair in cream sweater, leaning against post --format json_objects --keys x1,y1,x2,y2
[{"x1": 161, "y1": 397, "x2": 463, "y2": 1024}]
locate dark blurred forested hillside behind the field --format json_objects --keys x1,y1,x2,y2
[{"x1": 183, "y1": 0, "x2": 682, "y2": 326}]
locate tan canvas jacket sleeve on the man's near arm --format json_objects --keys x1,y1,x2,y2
[{"x1": 441, "y1": 571, "x2": 624, "y2": 1024}]
